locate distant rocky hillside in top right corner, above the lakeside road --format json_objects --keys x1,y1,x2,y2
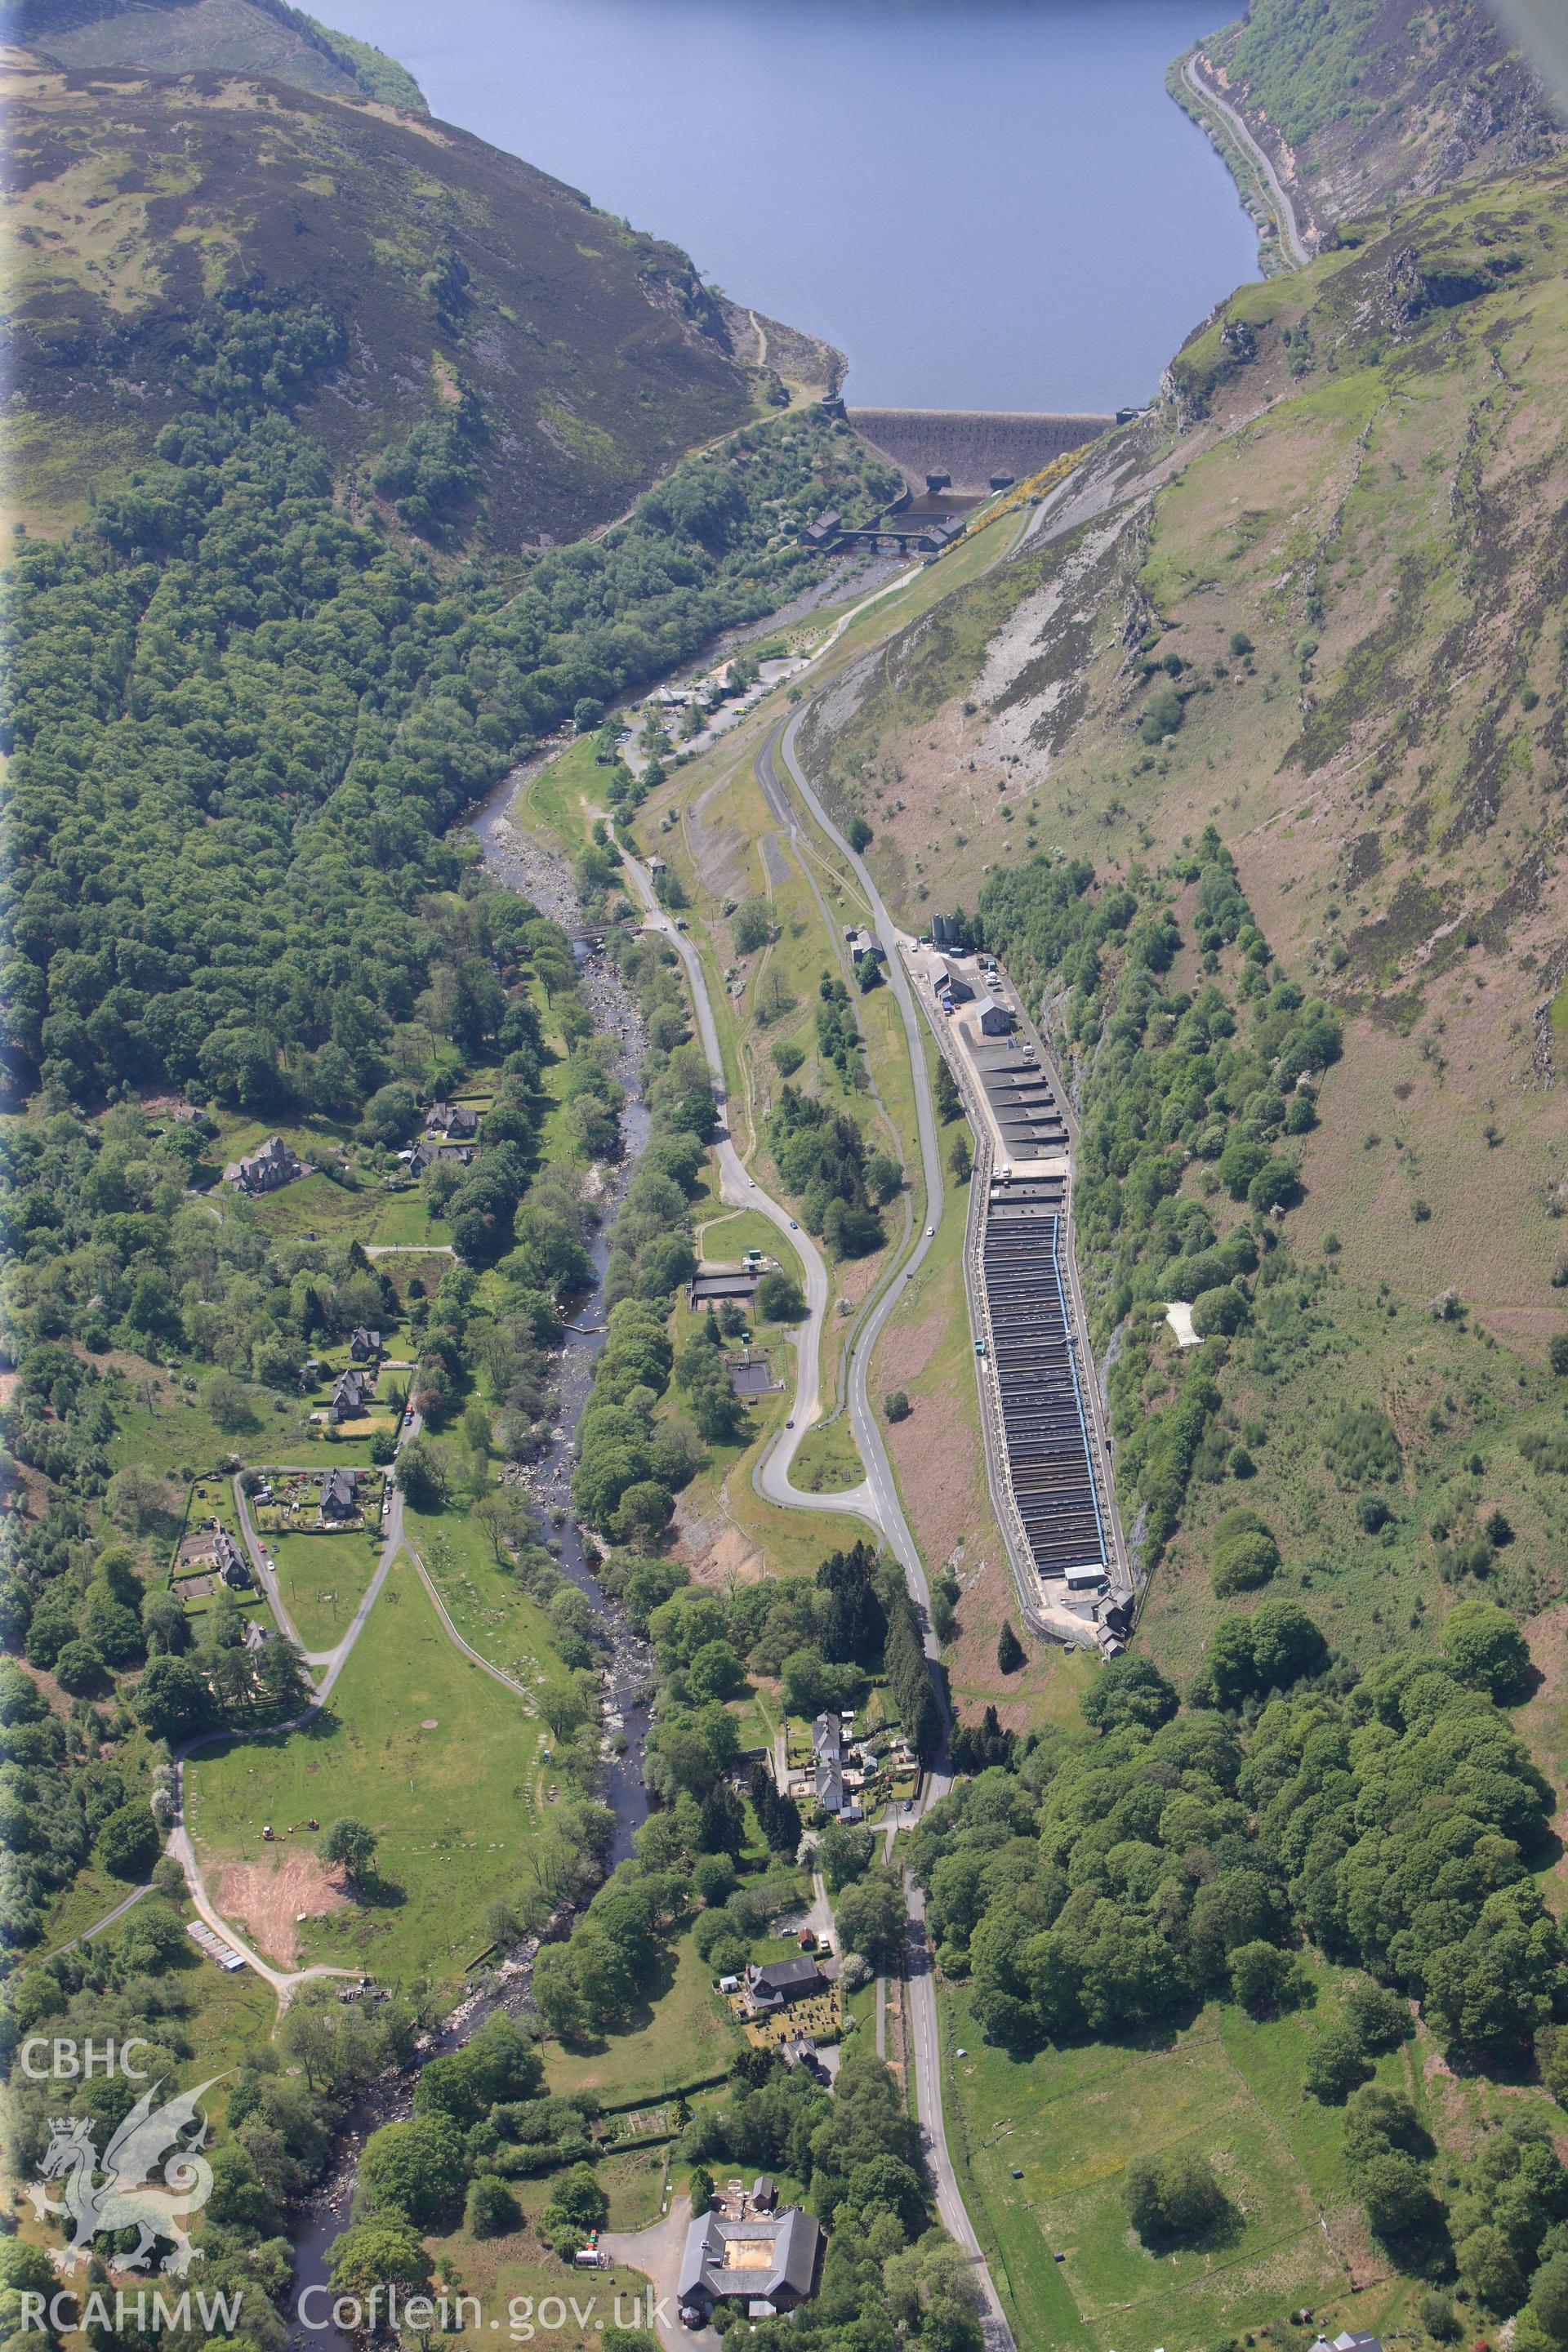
[{"x1": 1201, "y1": 0, "x2": 1563, "y2": 238}]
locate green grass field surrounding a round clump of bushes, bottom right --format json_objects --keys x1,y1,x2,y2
[{"x1": 942, "y1": 1967, "x2": 1434, "y2": 2352}]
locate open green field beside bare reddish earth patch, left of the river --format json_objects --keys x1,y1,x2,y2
[{"x1": 185, "y1": 1559, "x2": 552, "y2": 1983}]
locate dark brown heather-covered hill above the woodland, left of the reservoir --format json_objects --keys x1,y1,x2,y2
[{"x1": 7, "y1": 59, "x2": 780, "y2": 548}]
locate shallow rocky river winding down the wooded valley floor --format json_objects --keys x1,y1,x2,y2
[{"x1": 292, "y1": 774, "x2": 653, "y2": 2345}]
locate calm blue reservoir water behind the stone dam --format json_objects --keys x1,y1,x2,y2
[{"x1": 322, "y1": 0, "x2": 1258, "y2": 409}]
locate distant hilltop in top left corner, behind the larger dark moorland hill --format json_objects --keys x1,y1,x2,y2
[{"x1": 7, "y1": 0, "x2": 430, "y2": 115}]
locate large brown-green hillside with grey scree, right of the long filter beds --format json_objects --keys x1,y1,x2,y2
[{"x1": 806, "y1": 151, "x2": 1568, "y2": 1665}]
